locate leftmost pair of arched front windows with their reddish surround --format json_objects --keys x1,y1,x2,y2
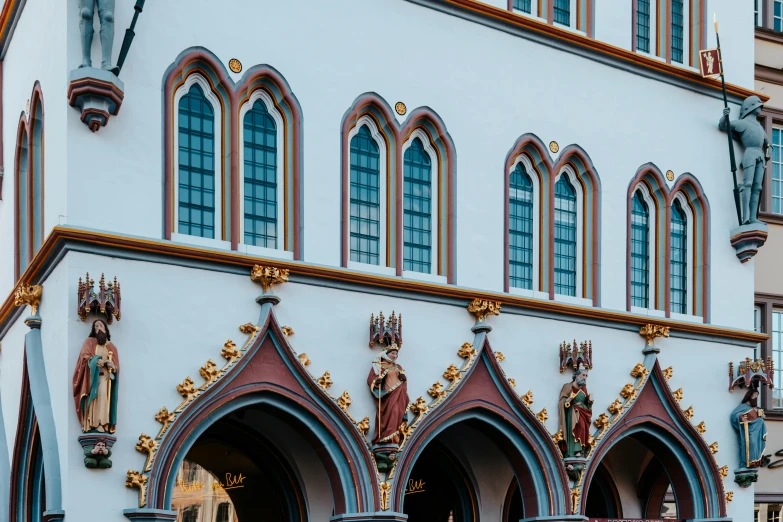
[{"x1": 163, "y1": 47, "x2": 302, "y2": 259}]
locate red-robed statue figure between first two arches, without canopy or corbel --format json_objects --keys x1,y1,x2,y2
[{"x1": 367, "y1": 344, "x2": 410, "y2": 444}]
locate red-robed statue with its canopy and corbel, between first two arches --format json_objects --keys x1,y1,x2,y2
[{"x1": 367, "y1": 312, "x2": 410, "y2": 472}]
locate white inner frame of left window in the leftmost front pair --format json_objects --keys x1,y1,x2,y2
[{"x1": 171, "y1": 72, "x2": 231, "y2": 248}]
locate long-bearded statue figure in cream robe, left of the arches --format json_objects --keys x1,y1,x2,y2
[{"x1": 73, "y1": 319, "x2": 120, "y2": 433}]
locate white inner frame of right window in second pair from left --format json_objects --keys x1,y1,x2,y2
[{"x1": 402, "y1": 127, "x2": 446, "y2": 283}]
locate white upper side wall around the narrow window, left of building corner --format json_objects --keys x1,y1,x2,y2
[{"x1": 0, "y1": 0, "x2": 67, "y2": 296}]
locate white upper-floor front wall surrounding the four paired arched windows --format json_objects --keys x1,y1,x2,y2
[{"x1": 52, "y1": 0, "x2": 753, "y2": 328}]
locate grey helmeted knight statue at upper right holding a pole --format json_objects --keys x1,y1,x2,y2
[{"x1": 718, "y1": 96, "x2": 769, "y2": 225}]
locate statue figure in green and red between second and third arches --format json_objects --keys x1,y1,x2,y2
[{"x1": 559, "y1": 368, "x2": 593, "y2": 458}]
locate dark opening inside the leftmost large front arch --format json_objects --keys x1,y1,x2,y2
[{"x1": 171, "y1": 406, "x2": 318, "y2": 522}]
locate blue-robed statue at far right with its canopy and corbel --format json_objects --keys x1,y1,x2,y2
[{"x1": 729, "y1": 357, "x2": 775, "y2": 488}]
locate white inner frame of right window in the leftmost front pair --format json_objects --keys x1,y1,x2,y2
[{"x1": 237, "y1": 88, "x2": 294, "y2": 259}]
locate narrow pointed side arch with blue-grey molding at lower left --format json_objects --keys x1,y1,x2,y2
[{"x1": 8, "y1": 344, "x2": 65, "y2": 522}]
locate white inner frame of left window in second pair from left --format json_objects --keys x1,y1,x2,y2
[{"x1": 345, "y1": 114, "x2": 392, "y2": 275}]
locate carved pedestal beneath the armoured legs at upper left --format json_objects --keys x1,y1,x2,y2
[{"x1": 68, "y1": 67, "x2": 125, "y2": 132}]
